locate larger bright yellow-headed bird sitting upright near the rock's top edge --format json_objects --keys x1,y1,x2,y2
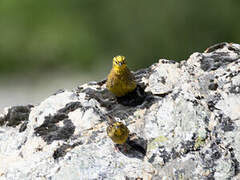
[{"x1": 107, "y1": 56, "x2": 137, "y2": 97}]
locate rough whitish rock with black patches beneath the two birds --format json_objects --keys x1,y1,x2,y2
[{"x1": 0, "y1": 43, "x2": 240, "y2": 180}]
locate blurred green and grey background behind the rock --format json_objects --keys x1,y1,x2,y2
[{"x1": 0, "y1": 0, "x2": 240, "y2": 108}]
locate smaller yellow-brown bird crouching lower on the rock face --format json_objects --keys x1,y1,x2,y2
[{"x1": 107, "y1": 122, "x2": 129, "y2": 144}]
